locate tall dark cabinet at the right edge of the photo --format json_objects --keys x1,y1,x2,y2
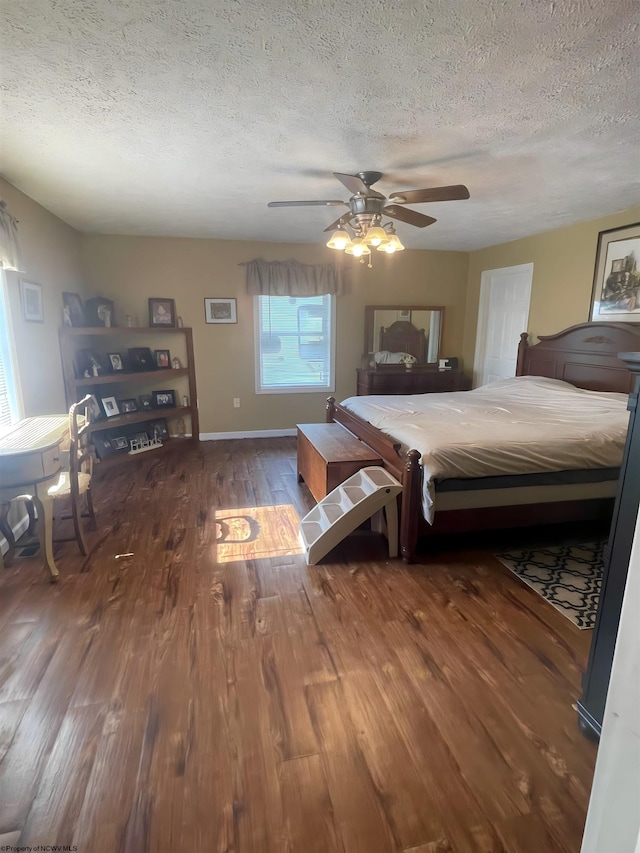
[{"x1": 578, "y1": 353, "x2": 640, "y2": 737}]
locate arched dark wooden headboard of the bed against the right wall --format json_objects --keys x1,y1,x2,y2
[{"x1": 516, "y1": 323, "x2": 640, "y2": 394}]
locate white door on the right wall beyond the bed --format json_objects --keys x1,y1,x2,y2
[{"x1": 473, "y1": 264, "x2": 533, "y2": 388}]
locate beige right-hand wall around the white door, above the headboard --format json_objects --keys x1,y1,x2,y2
[{"x1": 463, "y1": 207, "x2": 640, "y2": 371}]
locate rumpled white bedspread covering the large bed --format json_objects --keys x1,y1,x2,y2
[{"x1": 342, "y1": 376, "x2": 629, "y2": 523}]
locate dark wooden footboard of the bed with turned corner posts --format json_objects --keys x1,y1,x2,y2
[{"x1": 327, "y1": 397, "x2": 422, "y2": 562}]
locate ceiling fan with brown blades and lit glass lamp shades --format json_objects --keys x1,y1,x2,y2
[{"x1": 268, "y1": 172, "x2": 469, "y2": 258}]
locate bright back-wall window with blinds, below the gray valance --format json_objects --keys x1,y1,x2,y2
[{"x1": 255, "y1": 295, "x2": 335, "y2": 394}]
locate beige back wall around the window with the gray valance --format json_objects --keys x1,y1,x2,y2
[{"x1": 82, "y1": 235, "x2": 467, "y2": 433}]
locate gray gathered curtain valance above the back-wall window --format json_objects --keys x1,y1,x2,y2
[{"x1": 244, "y1": 258, "x2": 344, "y2": 296}]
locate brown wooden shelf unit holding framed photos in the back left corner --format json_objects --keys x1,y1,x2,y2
[{"x1": 59, "y1": 326, "x2": 200, "y2": 456}]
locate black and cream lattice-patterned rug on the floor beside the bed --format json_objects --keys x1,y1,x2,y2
[{"x1": 494, "y1": 542, "x2": 605, "y2": 628}]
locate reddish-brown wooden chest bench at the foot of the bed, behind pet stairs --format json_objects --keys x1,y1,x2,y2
[{"x1": 297, "y1": 424, "x2": 382, "y2": 501}]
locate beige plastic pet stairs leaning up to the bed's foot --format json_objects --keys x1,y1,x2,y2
[{"x1": 300, "y1": 466, "x2": 402, "y2": 566}]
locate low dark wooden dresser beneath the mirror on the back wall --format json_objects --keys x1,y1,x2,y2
[{"x1": 357, "y1": 364, "x2": 467, "y2": 396}]
